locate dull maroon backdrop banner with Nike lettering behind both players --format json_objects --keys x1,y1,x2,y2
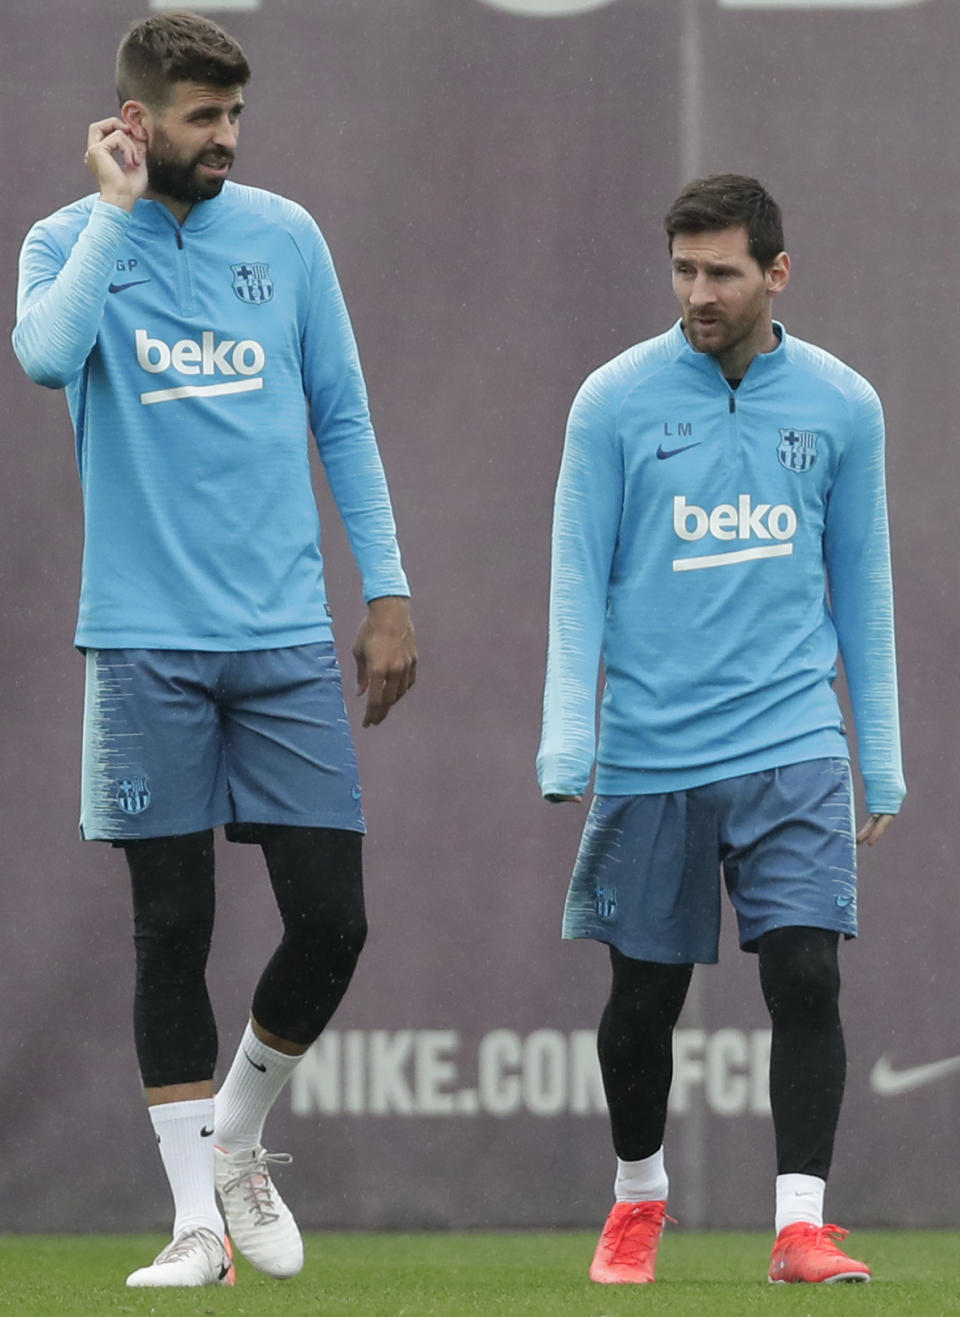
[{"x1": 0, "y1": 0, "x2": 960, "y2": 1230}]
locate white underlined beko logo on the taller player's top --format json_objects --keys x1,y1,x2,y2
[{"x1": 136, "y1": 329, "x2": 266, "y2": 406}]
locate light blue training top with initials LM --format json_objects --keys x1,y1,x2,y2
[{"x1": 537, "y1": 324, "x2": 905, "y2": 814}]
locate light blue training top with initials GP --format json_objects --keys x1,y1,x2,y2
[{"x1": 13, "y1": 183, "x2": 410, "y2": 651}]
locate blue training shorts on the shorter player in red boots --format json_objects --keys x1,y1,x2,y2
[{"x1": 564, "y1": 759, "x2": 857, "y2": 964}]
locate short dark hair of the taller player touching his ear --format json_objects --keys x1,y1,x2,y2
[{"x1": 117, "y1": 9, "x2": 250, "y2": 109}]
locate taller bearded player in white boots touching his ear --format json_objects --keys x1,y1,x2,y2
[{"x1": 13, "y1": 12, "x2": 416, "y2": 1287}]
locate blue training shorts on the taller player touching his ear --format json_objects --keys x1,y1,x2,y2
[{"x1": 80, "y1": 641, "x2": 365, "y2": 842}]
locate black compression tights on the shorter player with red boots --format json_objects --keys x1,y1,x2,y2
[{"x1": 597, "y1": 927, "x2": 847, "y2": 1180}]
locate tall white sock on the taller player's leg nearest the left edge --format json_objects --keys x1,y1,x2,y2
[{"x1": 147, "y1": 1097, "x2": 224, "y2": 1239}]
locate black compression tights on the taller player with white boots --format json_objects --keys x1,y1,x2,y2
[{"x1": 124, "y1": 827, "x2": 366, "y2": 1088}]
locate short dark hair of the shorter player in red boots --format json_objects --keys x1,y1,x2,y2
[{"x1": 664, "y1": 174, "x2": 784, "y2": 270}]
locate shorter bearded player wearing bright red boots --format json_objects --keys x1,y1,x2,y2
[{"x1": 537, "y1": 175, "x2": 905, "y2": 1283}]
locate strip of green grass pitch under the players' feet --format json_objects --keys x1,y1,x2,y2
[{"x1": 0, "y1": 1230, "x2": 960, "y2": 1317}]
